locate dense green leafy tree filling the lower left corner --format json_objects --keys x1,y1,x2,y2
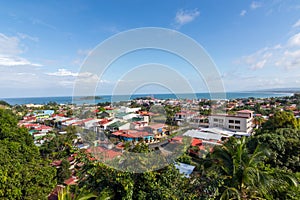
[{"x1": 0, "y1": 109, "x2": 56, "y2": 199}]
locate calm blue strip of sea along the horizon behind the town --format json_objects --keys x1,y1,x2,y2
[{"x1": 2, "y1": 92, "x2": 292, "y2": 105}]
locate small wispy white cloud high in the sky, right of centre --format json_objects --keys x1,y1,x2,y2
[{"x1": 175, "y1": 9, "x2": 200, "y2": 27}]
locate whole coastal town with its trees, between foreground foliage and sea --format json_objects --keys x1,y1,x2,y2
[{"x1": 1, "y1": 94, "x2": 300, "y2": 199}]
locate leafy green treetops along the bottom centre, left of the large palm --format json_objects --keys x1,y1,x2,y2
[{"x1": 79, "y1": 159, "x2": 196, "y2": 200}]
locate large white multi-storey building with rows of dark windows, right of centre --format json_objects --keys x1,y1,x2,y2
[{"x1": 208, "y1": 110, "x2": 253, "y2": 133}]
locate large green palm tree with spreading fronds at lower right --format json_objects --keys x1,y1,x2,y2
[{"x1": 211, "y1": 138, "x2": 297, "y2": 199}]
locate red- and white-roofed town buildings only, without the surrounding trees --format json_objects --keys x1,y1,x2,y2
[{"x1": 19, "y1": 96, "x2": 299, "y2": 195}]
